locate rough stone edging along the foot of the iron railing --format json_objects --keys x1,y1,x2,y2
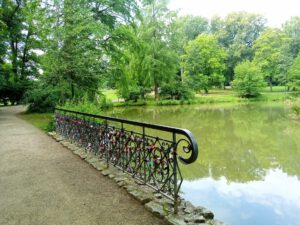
[{"x1": 48, "y1": 132, "x2": 225, "y2": 225}]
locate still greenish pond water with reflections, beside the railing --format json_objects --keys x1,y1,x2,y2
[{"x1": 109, "y1": 103, "x2": 300, "y2": 225}]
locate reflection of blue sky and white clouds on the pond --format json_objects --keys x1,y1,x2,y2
[{"x1": 183, "y1": 169, "x2": 300, "y2": 225}]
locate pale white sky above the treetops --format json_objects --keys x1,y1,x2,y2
[{"x1": 169, "y1": 0, "x2": 300, "y2": 28}]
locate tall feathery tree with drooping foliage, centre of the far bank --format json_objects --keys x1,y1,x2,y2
[{"x1": 114, "y1": 0, "x2": 179, "y2": 100}]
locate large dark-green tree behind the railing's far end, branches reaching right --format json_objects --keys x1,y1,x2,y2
[{"x1": 33, "y1": 0, "x2": 136, "y2": 105}]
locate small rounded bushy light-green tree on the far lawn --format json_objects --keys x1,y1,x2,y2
[{"x1": 232, "y1": 61, "x2": 265, "y2": 98}]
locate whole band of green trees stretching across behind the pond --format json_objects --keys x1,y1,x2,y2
[{"x1": 0, "y1": 0, "x2": 300, "y2": 110}]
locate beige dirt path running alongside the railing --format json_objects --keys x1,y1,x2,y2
[{"x1": 0, "y1": 107, "x2": 165, "y2": 225}]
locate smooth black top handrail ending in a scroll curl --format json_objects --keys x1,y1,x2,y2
[{"x1": 55, "y1": 108, "x2": 198, "y2": 164}]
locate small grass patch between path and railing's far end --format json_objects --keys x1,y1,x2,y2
[{"x1": 19, "y1": 113, "x2": 54, "y2": 132}]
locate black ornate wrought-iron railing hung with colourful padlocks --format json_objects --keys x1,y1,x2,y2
[{"x1": 55, "y1": 108, "x2": 198, "y2": 213}]
